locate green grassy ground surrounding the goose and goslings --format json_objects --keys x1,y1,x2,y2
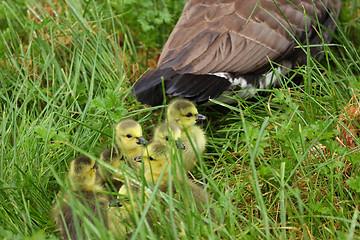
[{"x1": 0, "y1": 0, "x2": 360, "y2": 239}]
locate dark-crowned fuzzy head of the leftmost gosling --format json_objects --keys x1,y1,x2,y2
[{"x1": 69, "y1": 156, "x2": 97, "y2": 190}]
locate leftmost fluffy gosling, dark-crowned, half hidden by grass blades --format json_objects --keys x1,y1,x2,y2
[{"x1": 52, "y1": 156, "x2": 109, "y2": 239}]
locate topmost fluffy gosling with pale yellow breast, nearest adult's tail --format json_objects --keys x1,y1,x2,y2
[{"x1": 167, "y1": 98, "x2": 206, "y2": 171}]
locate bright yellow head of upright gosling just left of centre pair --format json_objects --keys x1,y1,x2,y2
[{"x1": 115, "y1": 119, "x2": 146, "y2": 150}]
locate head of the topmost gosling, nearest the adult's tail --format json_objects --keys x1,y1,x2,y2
[{"x1": 167, "y1": 98, "x2": 206, "y2": 128}]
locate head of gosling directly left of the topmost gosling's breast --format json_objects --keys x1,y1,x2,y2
[{"x1": 153, "y1": 122, "x2": 185, "y2": 149}]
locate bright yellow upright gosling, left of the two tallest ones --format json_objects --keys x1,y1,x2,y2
[{"x1": 115, "y1": 119, "x2": 146, "y2": 163}]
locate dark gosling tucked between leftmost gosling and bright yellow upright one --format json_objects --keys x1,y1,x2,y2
[{"x1": 96, "y1": 147, "x2": 124, "y2": 192}]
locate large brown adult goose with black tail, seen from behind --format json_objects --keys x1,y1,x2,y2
[{"x1": 133, "y1": 0, "x2": 341, "y2": 105}]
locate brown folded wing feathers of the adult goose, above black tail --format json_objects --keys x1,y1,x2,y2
[{"x1": 158, "y1": 0, "x2": 338, "y2": 74}]
